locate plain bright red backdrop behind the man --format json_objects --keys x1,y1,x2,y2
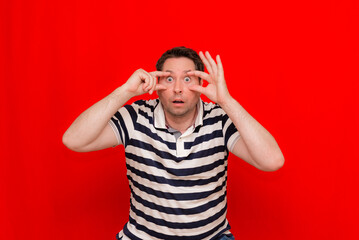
[{"x1": 0, "y1": 0, "x2": 359, "y2": 240}]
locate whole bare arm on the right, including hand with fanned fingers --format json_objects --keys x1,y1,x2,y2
[{"x1": 189, "y1": 52, "x2": 284, "y2": 171}]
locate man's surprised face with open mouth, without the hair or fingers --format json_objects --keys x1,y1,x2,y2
[{"x1": 157, "y1": 57, "x2": 201, "y2": 118}]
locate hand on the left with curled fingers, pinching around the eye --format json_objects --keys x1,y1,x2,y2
[{"x1": 123, "y1": 69, "x2": 171, "y2": 98}]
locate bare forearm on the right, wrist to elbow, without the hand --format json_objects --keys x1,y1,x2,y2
[{"x1": 220, "y1": 97, "x2": 284, "y2": 171}]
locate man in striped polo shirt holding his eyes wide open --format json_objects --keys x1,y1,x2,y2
[{"x1": 63, "y1": 47, "x2": 284, "y2": 240}]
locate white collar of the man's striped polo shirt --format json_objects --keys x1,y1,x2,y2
[{"x1": 153, "y1": 99, "x2": 203, "y2": 129}]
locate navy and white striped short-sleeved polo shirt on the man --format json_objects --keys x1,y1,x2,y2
[{"x1": 110, "y1": 99, "x2": 239, "y2": 240}]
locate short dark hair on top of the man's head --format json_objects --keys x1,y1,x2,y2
[{"x1": 156, "y1": 46, "x2": 204, "y2": 71}]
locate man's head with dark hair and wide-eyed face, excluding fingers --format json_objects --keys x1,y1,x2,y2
[{"x1": 156, "y1": 47, "x2": 204, "y2": 121}]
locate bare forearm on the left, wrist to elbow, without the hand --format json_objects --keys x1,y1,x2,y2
[{"x1": 63, "y1": 85, "x2": 131, "y2": 150}]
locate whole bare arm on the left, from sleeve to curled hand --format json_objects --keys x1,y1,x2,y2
[{"x1": 62, "y1": 69, "x2": 169, "y2": 152}]
